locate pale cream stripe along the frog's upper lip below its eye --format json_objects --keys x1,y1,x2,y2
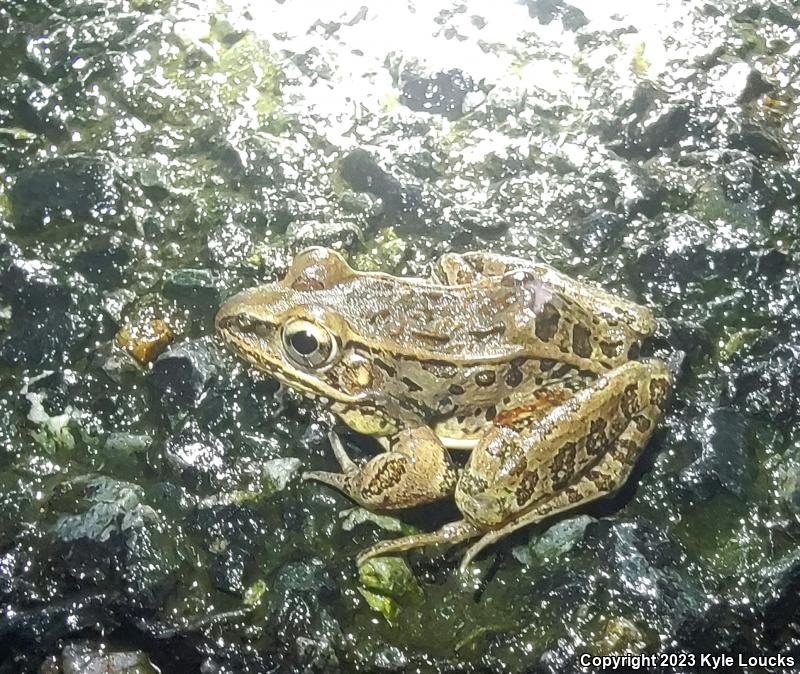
[{"x1": 217, "y1": 319, "x2": 364, "y2": 405}]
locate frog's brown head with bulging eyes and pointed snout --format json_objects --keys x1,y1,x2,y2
[{"x1": 216, "y1": 248, "x2": 382, "y2": 406}]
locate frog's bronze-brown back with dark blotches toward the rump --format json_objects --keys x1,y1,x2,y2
[{"x1": 322, "y1": 271, "x2": 640, "y2": 372}]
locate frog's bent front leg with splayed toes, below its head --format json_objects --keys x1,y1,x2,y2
[{"x1": 303, "y1": 426, "x2": 458, "y2": 510}]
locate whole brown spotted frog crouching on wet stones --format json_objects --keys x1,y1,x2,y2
[{"x1": 215, "y1": 247, "x2": 673, "y2": 572}]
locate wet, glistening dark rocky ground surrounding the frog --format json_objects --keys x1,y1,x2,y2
[{"x1": 0, "y1": 0, "x2": 800, "y2": 674}]
